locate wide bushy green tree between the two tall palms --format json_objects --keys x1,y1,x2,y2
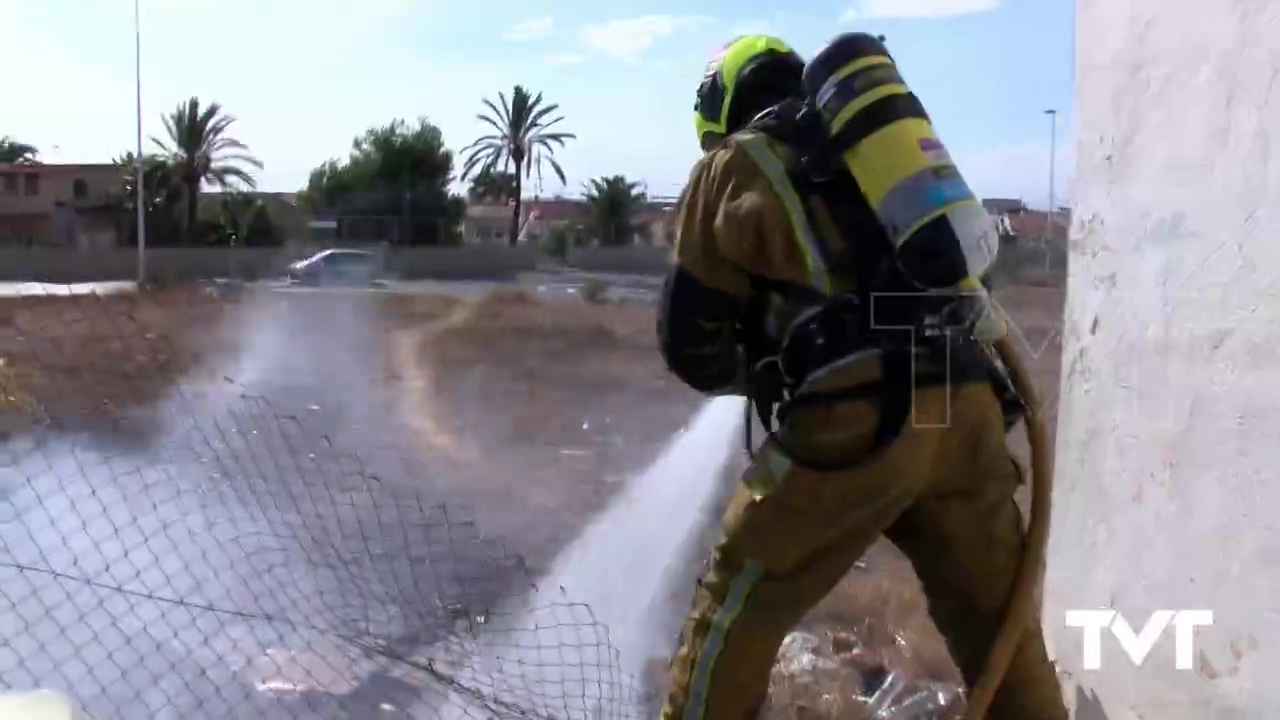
[{"x1": 302, "y1": 118, "x2": 466, "y2": 245}]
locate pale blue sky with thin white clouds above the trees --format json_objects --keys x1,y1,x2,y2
[{"x1": 0, "y1": 0, "x2": 1074, "y2": 206}]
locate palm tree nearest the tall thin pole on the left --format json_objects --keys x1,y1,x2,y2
[{"x1": 151, "y1": 97, "x2": 262, "y2": 243}]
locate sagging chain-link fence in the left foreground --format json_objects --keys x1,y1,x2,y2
[{"x1": 0, "y1": 283, "x2": 646, "y2": 720}]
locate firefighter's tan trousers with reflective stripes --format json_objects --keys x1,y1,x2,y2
[{"x1": 662, "y1": 358, "x2": 1068, "y2": 720}]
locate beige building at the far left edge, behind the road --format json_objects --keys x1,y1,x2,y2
[{"x1": 0, "y1": 164, "x2": 123, "y2": 249}]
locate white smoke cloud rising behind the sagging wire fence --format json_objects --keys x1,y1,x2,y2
[{"x1": 0, "y1": 285, "x2": 540, "y2": 720}]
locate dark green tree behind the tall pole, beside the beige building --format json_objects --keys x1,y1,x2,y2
[{"x1": 115, "y1": 152, "x2": 184, "y2": 245}]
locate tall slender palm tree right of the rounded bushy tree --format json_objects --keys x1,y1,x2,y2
[{"x1": 461, "y1": 85, "x2": 577, "y2": 247}]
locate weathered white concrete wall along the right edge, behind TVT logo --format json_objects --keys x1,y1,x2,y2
[{"x1": 1044, "y1": 0, "x2": 1280, "y2": 720}]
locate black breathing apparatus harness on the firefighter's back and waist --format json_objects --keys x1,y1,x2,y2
[{"x1": 739, "y1": 100, "x2": 1025, "y2": 471}]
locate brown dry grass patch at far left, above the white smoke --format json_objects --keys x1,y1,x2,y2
[{"x1": 0, "y1": 286, "x2": 235, "y2": 427}]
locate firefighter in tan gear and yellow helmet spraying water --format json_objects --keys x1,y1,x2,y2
[{"x1": 658, "y1": 36, "x2": 1068, "y2": 720}]
